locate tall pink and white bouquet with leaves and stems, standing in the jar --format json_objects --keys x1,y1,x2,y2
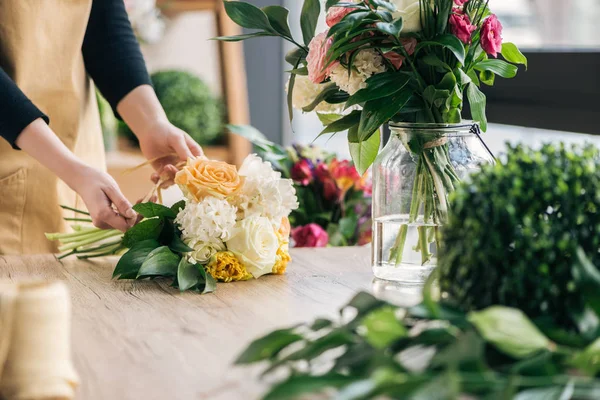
[{"x1": 218, "y1": 0, "x2": 527, "y2": 265}]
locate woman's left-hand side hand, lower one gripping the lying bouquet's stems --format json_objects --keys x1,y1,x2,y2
[{"x1": 68, "y1": 166, "x2": 137, "y2": 232}]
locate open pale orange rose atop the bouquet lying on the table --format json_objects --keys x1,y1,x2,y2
[{"x1": 175, "y1": 158, "x2": 243, "y2": 201}]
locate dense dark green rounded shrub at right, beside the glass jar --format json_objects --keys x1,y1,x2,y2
[{"x1": 438, "y1": 144, "x2": 600, "y2": 340}]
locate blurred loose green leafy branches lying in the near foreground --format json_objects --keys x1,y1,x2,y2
[{"x1": 236, "y1": 292, "x2": 600, "y2": 400}]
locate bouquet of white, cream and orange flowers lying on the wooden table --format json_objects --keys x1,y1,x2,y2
[{"x1": 46, "y1": 155, "x2": 298, "y2": 293}]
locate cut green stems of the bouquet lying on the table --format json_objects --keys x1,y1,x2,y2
[{"x1": 46, "y1": 206, "x2": 126, "y2": 260}]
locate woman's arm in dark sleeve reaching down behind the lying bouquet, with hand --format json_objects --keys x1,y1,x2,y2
[{"x1": 83, "y1": 0, "x2": 202, "y2": 171}]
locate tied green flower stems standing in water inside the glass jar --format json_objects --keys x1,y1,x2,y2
[{"x1": 390, "y1": 136, "x2": 460, "y2": 266}]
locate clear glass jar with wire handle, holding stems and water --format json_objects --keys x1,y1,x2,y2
[{"x1": 372, "y1": 122, "x2": 494, "y2": 284}]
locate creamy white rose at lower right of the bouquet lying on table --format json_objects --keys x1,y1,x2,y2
[{"x1": 227, "y1": 216, "x2": 279, "y2": 278}]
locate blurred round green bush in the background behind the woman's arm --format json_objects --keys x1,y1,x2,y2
[{"x1": 121, "y1": 70, "x2": 224, "y2": 145}]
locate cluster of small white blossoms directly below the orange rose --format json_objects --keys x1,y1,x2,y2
[{"x1": 175, "y1": 196, "x2": 237, "y2": 248}]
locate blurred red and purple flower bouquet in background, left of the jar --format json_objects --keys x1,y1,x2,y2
[{"x1": 229, "y1": 125, "x2": 372, "y2": 247}]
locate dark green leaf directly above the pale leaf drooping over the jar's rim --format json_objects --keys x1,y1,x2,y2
[{"x1": 358, "y1": 90, "x2": 412, "y2": 141}]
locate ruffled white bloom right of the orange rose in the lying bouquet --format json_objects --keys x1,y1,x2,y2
[{"x1": 234, "y1": 154, "x2": 298, "y2": 227}]
